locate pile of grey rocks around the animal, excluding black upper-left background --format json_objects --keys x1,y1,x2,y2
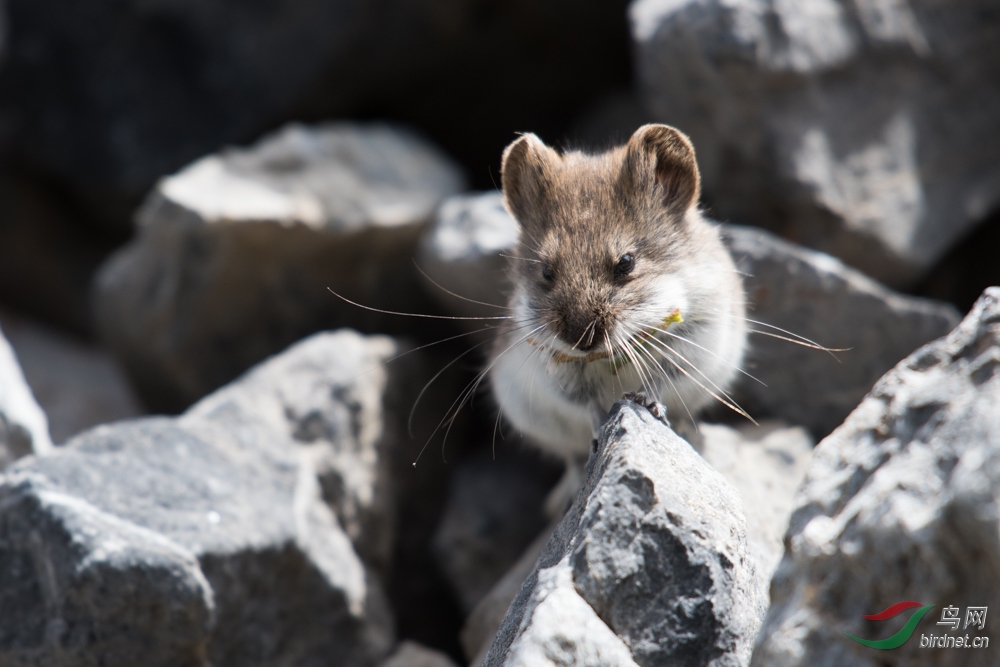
[{"x1": 0, "y1": 0, "x2": 1000, "y2": 667}]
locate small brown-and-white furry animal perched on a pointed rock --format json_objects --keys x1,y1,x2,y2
[{"x1": 488, "y1": 125, "x2": 747, "y2": 492}]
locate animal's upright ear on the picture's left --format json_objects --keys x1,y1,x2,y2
[{"x1": 500, "y1": 133, "x2": 560, "y2": 229}]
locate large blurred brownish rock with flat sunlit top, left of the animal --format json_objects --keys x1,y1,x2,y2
[{"x1": 95, "y1": 124, "x2": 462, "y2": 410}]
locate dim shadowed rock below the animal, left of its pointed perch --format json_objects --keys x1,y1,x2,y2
[{"x1": 433, "y1": 456, "x2": 553, "y2": 614}]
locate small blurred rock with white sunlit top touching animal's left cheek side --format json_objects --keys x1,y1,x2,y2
[{"x1": 419, "y1": 192, "x2": 517, "y2": 330}]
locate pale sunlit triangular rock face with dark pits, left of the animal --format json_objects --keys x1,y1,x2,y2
[{"x1": 180, "y1": 330, "x2": 410, "y2": 576}]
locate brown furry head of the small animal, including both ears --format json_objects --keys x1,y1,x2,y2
[{"x1": 502, "y1": 125, "x2": 700, "y2": 351}]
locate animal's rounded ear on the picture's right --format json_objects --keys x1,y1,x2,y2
[{"x1": 622, "y1": 125, "x2": 701, "y2": 215}]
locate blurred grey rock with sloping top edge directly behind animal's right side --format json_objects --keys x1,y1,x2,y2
[{"x1": 722, "y1": 225, "x2": 959, "y2": 437}]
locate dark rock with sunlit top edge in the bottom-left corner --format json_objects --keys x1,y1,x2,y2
[{"x1": 0, "y1": 470, "x2": 215, "y2": 667}]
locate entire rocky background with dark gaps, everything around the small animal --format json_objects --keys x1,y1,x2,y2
[{"x1": 0, "y1": 0, "x2": 1000, "y2": 667}]
